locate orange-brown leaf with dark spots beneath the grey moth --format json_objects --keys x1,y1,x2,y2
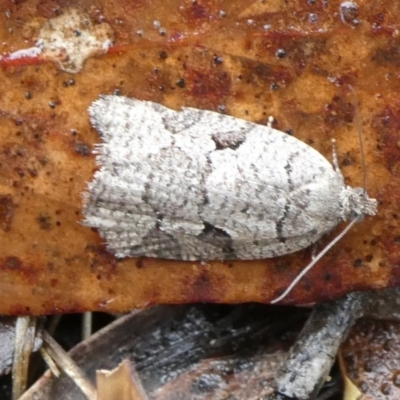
[{"x1": 0, "y1": 0, "x2": 400, "y2": 315}]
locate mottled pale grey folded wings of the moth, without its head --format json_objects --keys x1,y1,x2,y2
[{"x1": 84, "y1": 96, "x2": 344, "y2": 260}]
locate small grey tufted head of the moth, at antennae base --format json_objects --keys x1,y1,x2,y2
[{"x1": 340, "y1": 186, "x2": 378, "y2": 221}]
